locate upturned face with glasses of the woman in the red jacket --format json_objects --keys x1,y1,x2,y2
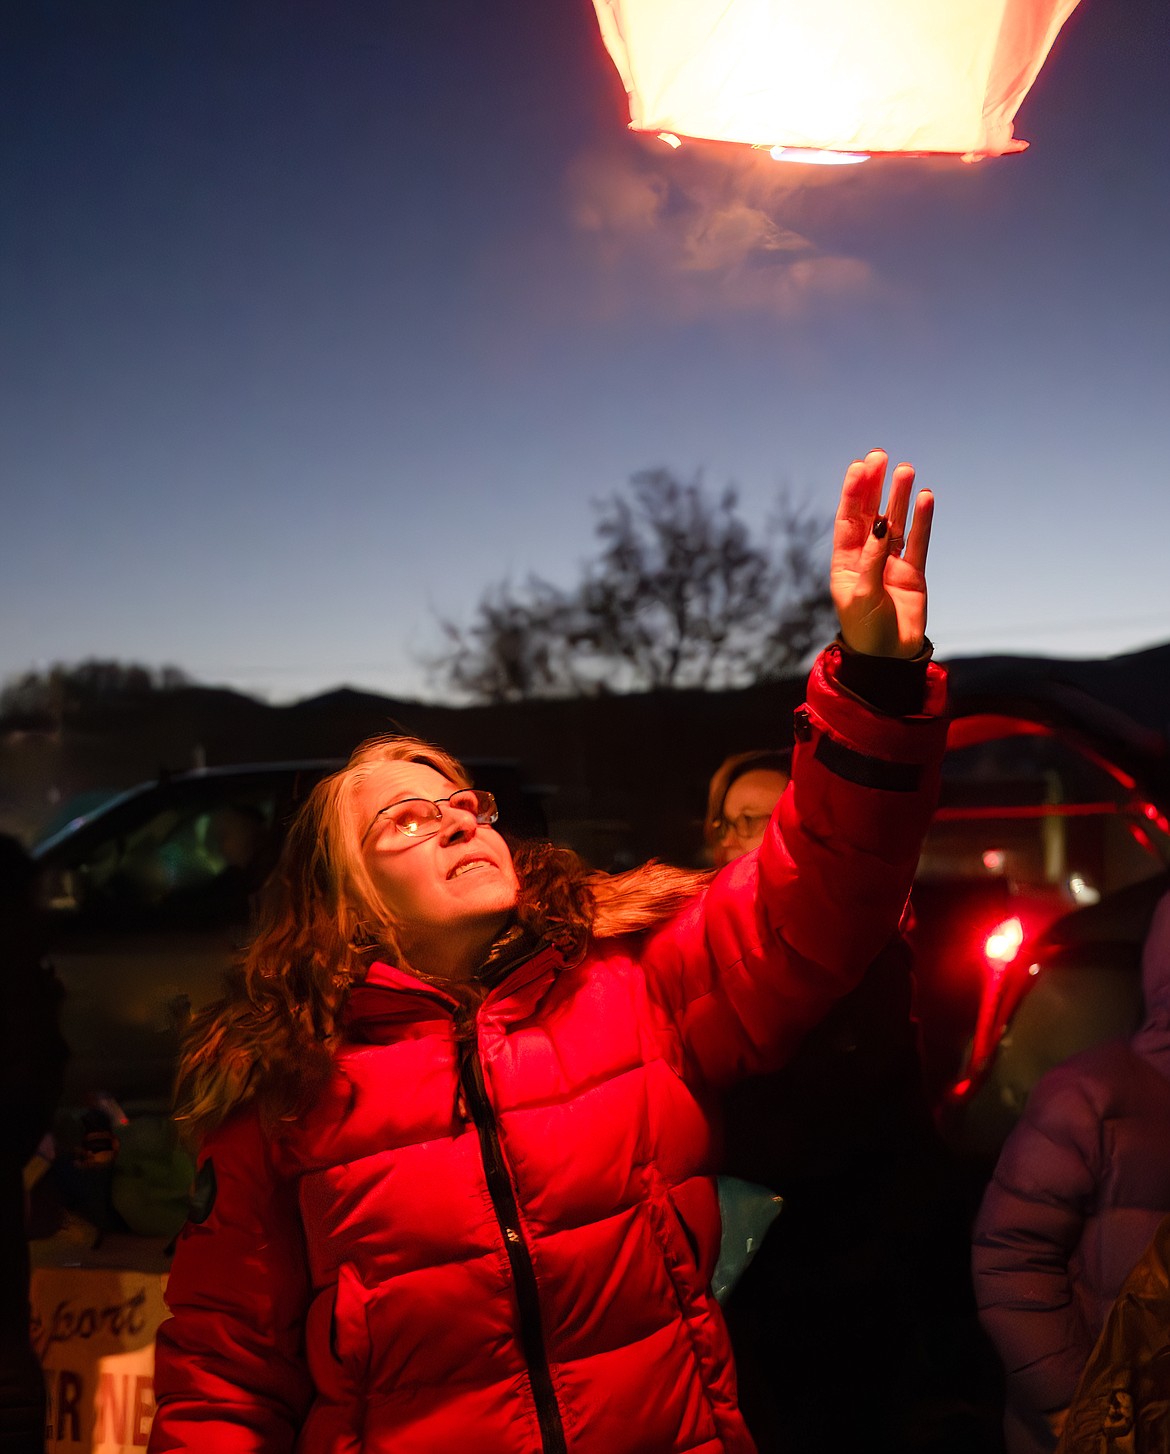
[{"x1": 355, "y1": 762, "x2": 519, "y2": 979}]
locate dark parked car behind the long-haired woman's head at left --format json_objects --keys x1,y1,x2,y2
[{"x1": 33, "y1": 759, "x2": 542, "y2": 1112}]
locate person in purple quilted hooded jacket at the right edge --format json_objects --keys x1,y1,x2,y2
[{"x1": 972, "y1": 894, "x2": 1170, "y2": 1454}]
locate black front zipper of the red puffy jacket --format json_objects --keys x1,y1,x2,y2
[{"x1": 459, "y1": 1040, "x2": 567, "y2": 1454}]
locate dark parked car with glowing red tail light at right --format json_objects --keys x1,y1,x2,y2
[{"x1": 911, "y1": 682, "x2": 1170, "y2": 1157}]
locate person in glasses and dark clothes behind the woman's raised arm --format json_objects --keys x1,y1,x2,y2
[{"x1": 705, "y1": 749, "x2": 981, "y2": 1454}]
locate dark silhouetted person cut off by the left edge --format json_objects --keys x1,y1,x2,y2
[{"x1": 0, "y1": 835, "x2": 67, "y2": 1454}]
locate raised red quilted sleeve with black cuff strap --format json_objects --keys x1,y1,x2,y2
[{"x1": 633, "y1": 647, "x2": 946, "y2": 1085}]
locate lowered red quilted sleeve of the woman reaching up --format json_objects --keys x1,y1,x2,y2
[{"x1": 150, "y1": 1112, "x2": 312, "y2": 1454}]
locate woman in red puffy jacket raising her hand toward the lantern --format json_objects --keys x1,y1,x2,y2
[{"x1": 150, "y1": 451, "x2": 943, "y2": 1454}]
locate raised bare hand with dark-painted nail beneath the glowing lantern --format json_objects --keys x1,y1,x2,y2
[{"x1": 828, "y1": 449, "x2": 935, "y2": 657}]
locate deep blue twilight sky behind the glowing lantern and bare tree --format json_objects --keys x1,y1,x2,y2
[{"x1": 0, "y1": 0, "x2": 1170, "y2": 701}]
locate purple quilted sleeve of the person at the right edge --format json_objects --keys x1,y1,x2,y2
[{"x1": 972, "y1": 1063, "x2": 1105, "y2": 1428}]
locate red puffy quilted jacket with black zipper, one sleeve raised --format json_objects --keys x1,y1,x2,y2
[{"x1": 150, "y1": 650, "x2": 943, "y2": 1454}]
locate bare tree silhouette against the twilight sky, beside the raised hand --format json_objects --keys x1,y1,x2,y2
[{"x1": 427, "y1": 470, "x2": 833, "y2": 702}]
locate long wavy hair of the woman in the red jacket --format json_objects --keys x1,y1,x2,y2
[{"x1": 176, "y1": 736, "x2": 711, "y2": 1144}]
